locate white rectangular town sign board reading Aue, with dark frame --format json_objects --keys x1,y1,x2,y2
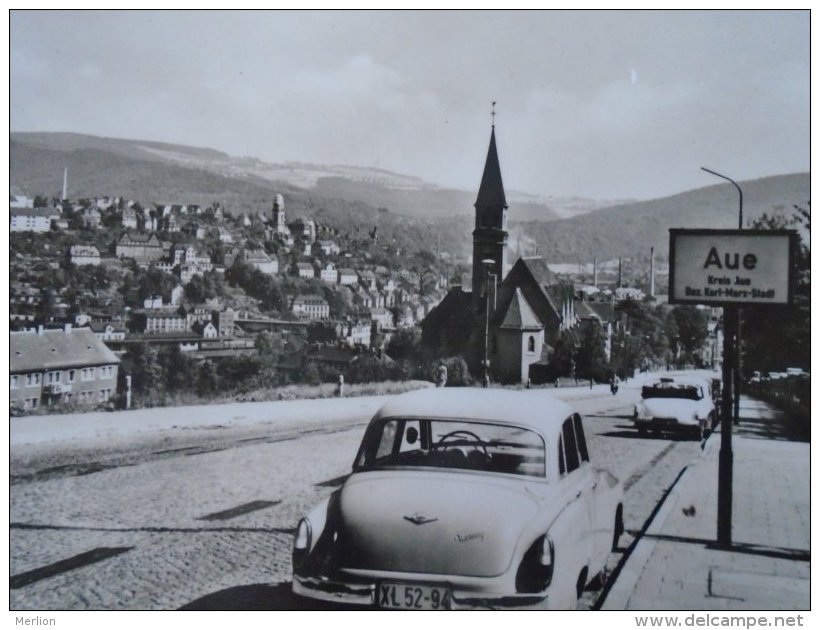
[{"x1": 669, "y1": 229, "x2": 797, "y2": 305}]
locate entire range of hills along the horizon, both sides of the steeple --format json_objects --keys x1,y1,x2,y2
[{"x1": 9, "y1": 133, "x2": 810, "y2": 262}]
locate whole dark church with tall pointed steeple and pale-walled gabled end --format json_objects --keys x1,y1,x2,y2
[{"x1": 422, "y1": 119, "x2": 615, "y2": 383}]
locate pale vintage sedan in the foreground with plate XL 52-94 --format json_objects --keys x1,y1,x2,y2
[{"x1": 293, "y1": 388, "x2": 623, "y2": 610}]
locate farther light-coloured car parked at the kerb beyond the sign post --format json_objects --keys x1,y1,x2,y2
[{"x1": 633, "y1": 378, "x2": 717, "y2": 440}]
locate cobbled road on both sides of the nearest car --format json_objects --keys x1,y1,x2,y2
[{"x1": 10, "y1": 382, "x2": 712, "y2": 610}]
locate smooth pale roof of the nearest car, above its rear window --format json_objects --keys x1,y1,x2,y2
[{"x1": 373, "y1": 387, "x2": 573, "y2": 434}]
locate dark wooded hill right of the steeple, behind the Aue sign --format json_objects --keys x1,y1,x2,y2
[{"x1": 510, "y1": 173, "x2": 811, "y2": 262}]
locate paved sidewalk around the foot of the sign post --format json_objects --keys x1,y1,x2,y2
[{"x1": 601, "y1": 398, "x2": 811, "y2": 611}]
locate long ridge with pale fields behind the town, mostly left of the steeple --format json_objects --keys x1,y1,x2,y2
[{"x1": 10, "y1": 133, "x2": 606, "y2": 221}]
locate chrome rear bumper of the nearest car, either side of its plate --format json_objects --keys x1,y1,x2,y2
[{"x1": 293, "y1": 575, "x2": 548, "y2": 610}]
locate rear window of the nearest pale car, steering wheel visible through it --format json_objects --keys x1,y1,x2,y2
[{"x1": 354, "y1": 418, "x2": 546, "y2": 477}]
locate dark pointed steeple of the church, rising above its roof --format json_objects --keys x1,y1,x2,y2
[{"x1": 472, "y1": 119, "x2": 507, "y2": 309}]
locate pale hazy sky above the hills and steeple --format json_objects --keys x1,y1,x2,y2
[{"x1": 10, "y1": 11, "x2": 810, "y2": 199}]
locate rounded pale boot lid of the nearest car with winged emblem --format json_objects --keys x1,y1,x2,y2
[{"x1": 339, "y1": 471, "x2": 539, "y2": 577}]
